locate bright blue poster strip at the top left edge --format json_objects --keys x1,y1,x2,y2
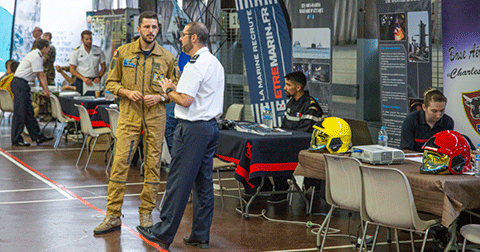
[{"x1": 0, "y1": 0, "x2": 15, "y2": 73}]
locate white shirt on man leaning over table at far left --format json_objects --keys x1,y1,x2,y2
[{"x1": 14, "y1": 49, "x2": 43, "y2": 83}]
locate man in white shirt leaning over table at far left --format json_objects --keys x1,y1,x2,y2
[{"x1": 11, "y1": 39, "x2": 53, "y2": 146}]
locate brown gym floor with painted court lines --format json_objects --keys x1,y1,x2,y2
[{"x1": 0, "y1": 113, "x2": 442, "y2": 251}]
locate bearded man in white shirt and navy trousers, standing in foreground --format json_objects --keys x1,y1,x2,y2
[{"x1": 137, "y1": 22, "x2": 225, "y2": 249}]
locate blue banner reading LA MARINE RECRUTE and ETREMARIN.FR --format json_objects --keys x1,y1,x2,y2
[{"x1": 235, "y1": 0, "x2": 292, "y2": 127}]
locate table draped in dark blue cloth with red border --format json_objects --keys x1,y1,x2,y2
[{"x1": 215, "y1": 130, "x2": 311, "y2": 218}]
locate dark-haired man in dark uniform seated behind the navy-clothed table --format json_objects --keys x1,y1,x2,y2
[{"x1": 268, "y1": 71, "x2": 323, "y2": 203}]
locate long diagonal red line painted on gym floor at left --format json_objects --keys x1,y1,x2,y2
[{"x1": 0, "y1": 148, "x2": 168, "y2": 251}]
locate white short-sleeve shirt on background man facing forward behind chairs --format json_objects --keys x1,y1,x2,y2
[{"x1": 68, "y1": 44, "x2": 105, "y2": 78}]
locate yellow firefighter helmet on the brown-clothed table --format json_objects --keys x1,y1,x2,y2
[{"x1": 309, "y1": 117, "x2": 352, "y2": 153}]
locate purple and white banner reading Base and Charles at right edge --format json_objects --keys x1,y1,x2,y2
[{"x1": 442, "y1": 0, "x2": 480, "y2": 144}]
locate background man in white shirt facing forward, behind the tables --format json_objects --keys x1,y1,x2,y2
[{"x1": 68, "y1": 30, "x2": 107, "y2": 94}]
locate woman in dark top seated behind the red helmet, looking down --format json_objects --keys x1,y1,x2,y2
[{"x1": 400, "y1": 89, "x2": 454, "y2": 152}]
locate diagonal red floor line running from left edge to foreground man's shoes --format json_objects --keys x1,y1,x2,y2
[{"x1": 0, "y1": 148, "x2": 167, "y2": 252}]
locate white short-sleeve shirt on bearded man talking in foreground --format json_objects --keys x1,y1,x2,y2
[{"x1": 175, "y1": 47, "x2": 225, "y2": 121}]
